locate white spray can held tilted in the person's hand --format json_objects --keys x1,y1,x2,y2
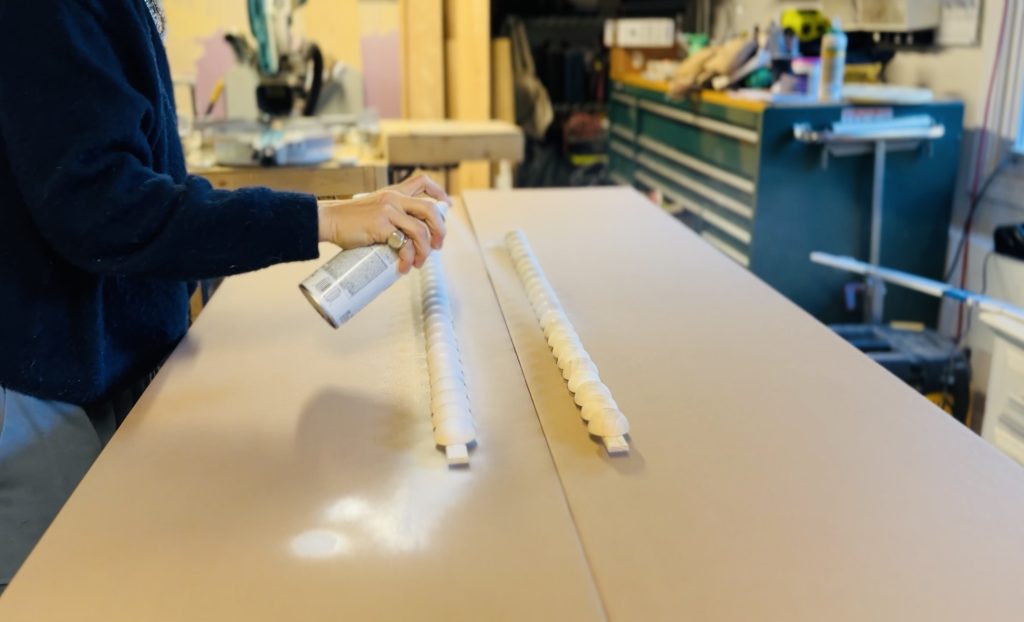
[{"x1": 299, "y1": 202, "x2": 449, "y2": 328}]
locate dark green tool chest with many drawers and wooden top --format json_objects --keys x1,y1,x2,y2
[{"x1": 608, "y1": 82, "x2": 964, "y2": 326}]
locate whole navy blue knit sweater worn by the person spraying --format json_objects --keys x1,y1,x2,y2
[{"x1": 0, "y1": 0, "x2": 317, "y2": 405}]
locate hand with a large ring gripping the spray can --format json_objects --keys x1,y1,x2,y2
[{"x1": 319, "y1": 175, "x2": 452, "y2": 274}]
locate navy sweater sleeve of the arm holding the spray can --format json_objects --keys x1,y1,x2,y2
[{"x1": 0, "y1": 0, "x2": 317, "y2": 280}]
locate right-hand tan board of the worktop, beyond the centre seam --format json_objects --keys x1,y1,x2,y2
[{"x1": 466, "y1": 189, "x2": 1024, "y2": 621}]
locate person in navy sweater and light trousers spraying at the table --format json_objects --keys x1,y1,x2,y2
[{"x1": 0, "y1": 0, "x2": 449, "y2": 590}]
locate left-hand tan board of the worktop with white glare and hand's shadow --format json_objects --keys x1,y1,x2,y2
[{"x1": 0, "y1": 205, "x2": 604, "y2": 622}]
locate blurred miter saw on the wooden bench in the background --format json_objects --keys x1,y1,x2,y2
[{"x1": 207, "y1": 0, "x2": 362, "y2": 166}]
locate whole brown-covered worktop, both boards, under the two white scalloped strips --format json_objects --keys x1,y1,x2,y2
[{"x1": 0, "y1": 189, "x2": 1024, "y2": 622}]
